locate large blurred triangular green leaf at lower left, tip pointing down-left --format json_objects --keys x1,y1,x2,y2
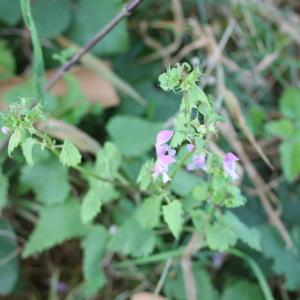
[{"x1": 22, "y1": 200, "x2": 87, "y2": 258}]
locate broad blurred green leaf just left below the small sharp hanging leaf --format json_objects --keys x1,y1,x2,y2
[{"x1": 108, "y1": 218, "x2": 155, "y2": 257}]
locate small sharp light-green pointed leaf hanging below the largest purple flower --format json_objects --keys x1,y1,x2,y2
[{"x1": 162, "y1": 200, "x2": 183, "y2": 239}]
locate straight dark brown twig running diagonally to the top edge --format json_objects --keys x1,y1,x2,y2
[{"x1": 46, "y1": 0, "x2": 142, "y2": 91}]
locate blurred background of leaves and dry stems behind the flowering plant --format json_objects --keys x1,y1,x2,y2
[{"x1": 0, "y1": 0, "x2": 300, "y2": 300}]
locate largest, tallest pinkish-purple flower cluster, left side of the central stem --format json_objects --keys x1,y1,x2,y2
[{"x1": 153, "y1": 130, "x2": 176, "y2": 183}]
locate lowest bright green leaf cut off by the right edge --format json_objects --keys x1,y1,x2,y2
[{"x1": 279, "y1": 134, "x2": 300, "y2": 182}]
